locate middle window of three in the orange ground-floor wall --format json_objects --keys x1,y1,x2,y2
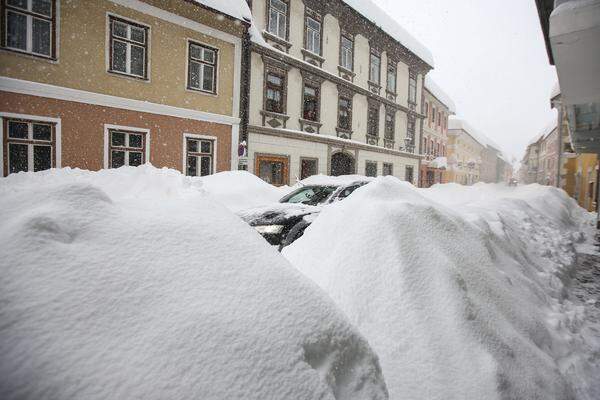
[{"x1": 108, "y1": 129, "x2": 146, "y2": 168}]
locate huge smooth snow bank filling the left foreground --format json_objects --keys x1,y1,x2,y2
[{"x1": 0, "y1": 166, "x2": 387, "y2": 400}]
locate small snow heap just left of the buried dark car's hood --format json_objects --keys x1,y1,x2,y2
[{"x1": 197, "y1": 171, "x2": 290, "y2": 212}]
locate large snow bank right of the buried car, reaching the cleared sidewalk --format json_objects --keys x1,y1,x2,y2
[{"x1": 284, "y1": 177, "x2": 598, "y2": 400}]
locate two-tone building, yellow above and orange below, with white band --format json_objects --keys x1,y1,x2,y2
[{"x1": 0, "y1": 0, "x2": 248, "y2": 175}]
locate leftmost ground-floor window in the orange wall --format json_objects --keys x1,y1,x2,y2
[{"x1": 3, "y1": 119, "x2": 56, "y2": 175}]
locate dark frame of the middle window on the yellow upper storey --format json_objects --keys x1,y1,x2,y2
[{"x1": 106, "y1": 13, "x2": 151, "y2": 82}]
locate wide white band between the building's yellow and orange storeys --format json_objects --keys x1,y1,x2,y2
[{"x1": 0, "y1": 77, "x2": 240, "y2": 125}]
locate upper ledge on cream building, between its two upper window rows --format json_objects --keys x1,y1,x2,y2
[{"x1": 252, "y1": 43, "x2": 425, "y2": 119}]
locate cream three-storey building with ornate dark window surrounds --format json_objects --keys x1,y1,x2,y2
[{"x1": 242, "y1": 0, "x2": 433, "y2": 185}]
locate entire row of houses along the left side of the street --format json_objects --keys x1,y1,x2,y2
[{"x1": 0, "y1": 0, "x2": 510, "y2": 186}]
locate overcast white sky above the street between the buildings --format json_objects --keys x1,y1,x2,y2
[{"x1": 374, "y1": 0, "x2": 556, "y2": 159}]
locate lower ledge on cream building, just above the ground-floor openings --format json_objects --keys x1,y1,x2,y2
[{"x1": 248, "y1": 125, "x2": 423, "y2": 160}]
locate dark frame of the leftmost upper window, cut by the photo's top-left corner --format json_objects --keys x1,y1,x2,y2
[{"x1": 0, "y1": 0, "x2": 60, "y2": 61}]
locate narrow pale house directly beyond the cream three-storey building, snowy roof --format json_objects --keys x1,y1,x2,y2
[{"x1": 420, "y1": 76, "x2": 456, "y2": 187}]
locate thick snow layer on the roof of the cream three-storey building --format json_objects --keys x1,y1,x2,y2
[{"x1": 340, "y1": 0, "x2": 434, "y2": 67}]
